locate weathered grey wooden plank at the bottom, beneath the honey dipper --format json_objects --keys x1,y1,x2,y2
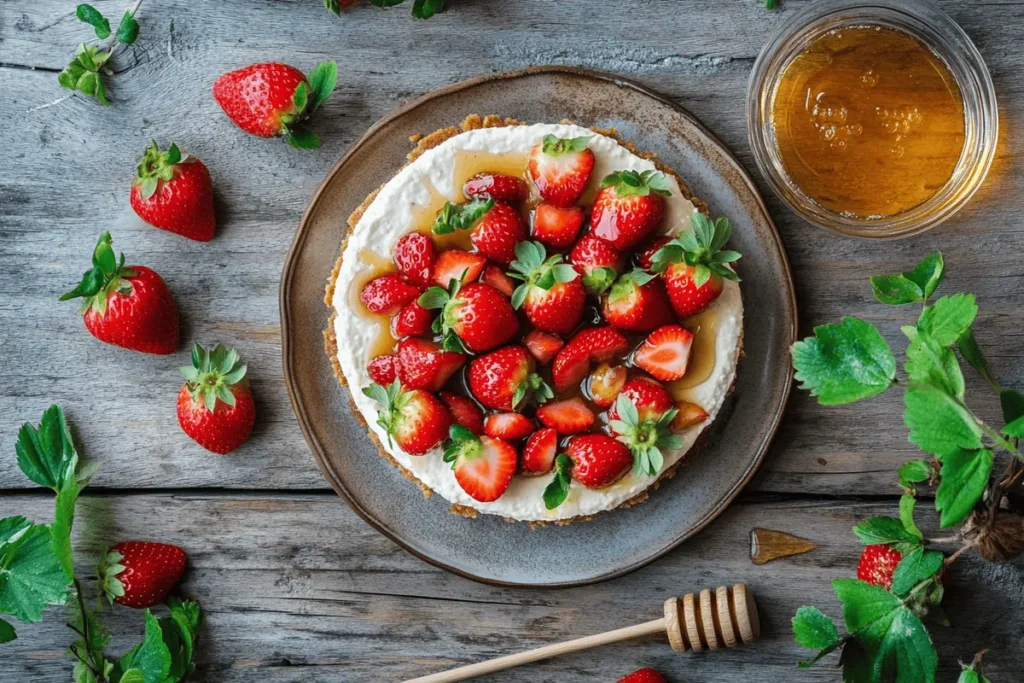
[{"x1": 0, "y1": 495, "x2": 1024, "y2": 683}]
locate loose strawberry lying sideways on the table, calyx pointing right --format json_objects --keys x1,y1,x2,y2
[{"x1": 213, "y1": 61, "x2": 338, "y2": 150}]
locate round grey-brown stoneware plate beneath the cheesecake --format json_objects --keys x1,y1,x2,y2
[{"x1": 281, "y1": 67, "x2": 797, "y2": 586}]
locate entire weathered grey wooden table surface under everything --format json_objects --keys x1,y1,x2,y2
[{"x1": 0, "y1": 0, "x2": 1024, "y2": 683}]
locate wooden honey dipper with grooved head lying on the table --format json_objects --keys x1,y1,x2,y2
[{"x1": 404, "y1": 584, "x2": 761, "y2": 683}]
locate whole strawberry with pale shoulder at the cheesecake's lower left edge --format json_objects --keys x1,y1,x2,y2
[{"x1": 362, "y1": 381, "x2": 452, "y2": 456}]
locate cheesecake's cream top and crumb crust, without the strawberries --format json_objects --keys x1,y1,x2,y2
[{"x1": 327, "y1": 118, "x2": 743, "y2": 522}]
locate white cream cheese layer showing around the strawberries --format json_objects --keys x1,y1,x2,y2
[{"x1": 334, "y1": 124, "x2": 743, "y2": 521}]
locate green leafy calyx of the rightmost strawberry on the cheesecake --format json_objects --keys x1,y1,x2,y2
[{"x1": 651, "y1": 213, "x2": 740, "y2": 289}]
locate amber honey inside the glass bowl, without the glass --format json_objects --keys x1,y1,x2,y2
[{"x1": 771, "y1": 26, "x2": 965, "y2": 218}]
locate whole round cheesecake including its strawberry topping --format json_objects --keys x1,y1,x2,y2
[{"x1": 326, "y1": 118, "x2": 742, "y2": 522}]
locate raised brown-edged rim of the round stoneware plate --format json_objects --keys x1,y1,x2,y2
[{"x1": 278, "y1": 65, "x2": 799, "y2": 588}]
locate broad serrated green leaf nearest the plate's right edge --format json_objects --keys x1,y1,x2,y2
[{"x1": 792, "y1": 317, "x2": 896, "y2": 405}]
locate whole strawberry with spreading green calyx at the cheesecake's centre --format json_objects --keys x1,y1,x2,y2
[{"x1": 509, "y1": 242, "x2": 587, "y2": 335}]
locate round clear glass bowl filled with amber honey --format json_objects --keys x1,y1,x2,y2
[{"x1": 746, "y1": 0, "x2": 998, "y2": 239}]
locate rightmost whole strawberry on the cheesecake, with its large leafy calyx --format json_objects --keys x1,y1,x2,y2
[{"x1": 652, "y1": 213, "x2": 739, "y2": 317}]
